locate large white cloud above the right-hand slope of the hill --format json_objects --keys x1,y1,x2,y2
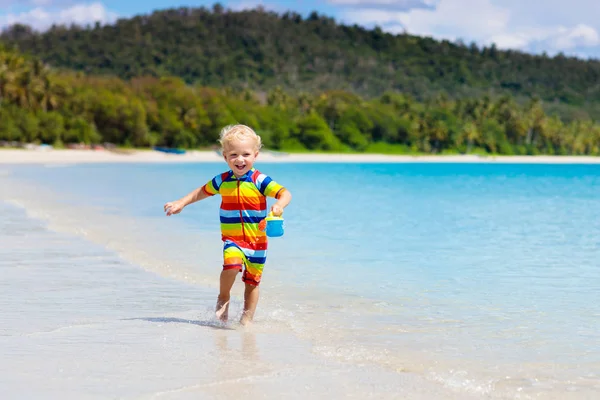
[{"x1": 336, "y1": 0, "x2": 600, "y2": 54}]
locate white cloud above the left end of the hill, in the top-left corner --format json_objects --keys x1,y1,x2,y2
[{"x1": 0, "y1": 3, "x2": 118, "y2": 31}]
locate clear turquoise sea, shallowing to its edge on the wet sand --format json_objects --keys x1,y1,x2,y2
[{"x1": 1, "y1": 163, "x2": 600, "y2": 398}]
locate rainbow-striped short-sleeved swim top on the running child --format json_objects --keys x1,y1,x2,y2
[{"x1": 202, "y1": 168, "x2": 285, "y2": 250}]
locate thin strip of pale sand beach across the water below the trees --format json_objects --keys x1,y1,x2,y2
[{"x1": 0, "y1": 149, "x2": 600, "y2": 164}]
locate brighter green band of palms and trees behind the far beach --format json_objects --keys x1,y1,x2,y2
[{"x1": 0, "y1": 47, "x2": 600, "y2": 155}]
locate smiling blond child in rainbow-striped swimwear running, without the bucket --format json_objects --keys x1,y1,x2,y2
[{"x1": 164, "y1": 125, "x2": 292, "y2": 325}]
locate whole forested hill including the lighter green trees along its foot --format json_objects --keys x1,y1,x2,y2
[{"x1": 0, "y1": 7, "x2": 600, "y2": 155}]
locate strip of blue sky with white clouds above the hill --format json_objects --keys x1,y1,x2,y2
[{"x1": 0, "y1": 0, "x2": 600, "y2": 59}]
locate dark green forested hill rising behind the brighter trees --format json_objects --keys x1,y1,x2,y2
[{"x1": 0, "y1": 5, "x2": 600, "y2": 120}]
